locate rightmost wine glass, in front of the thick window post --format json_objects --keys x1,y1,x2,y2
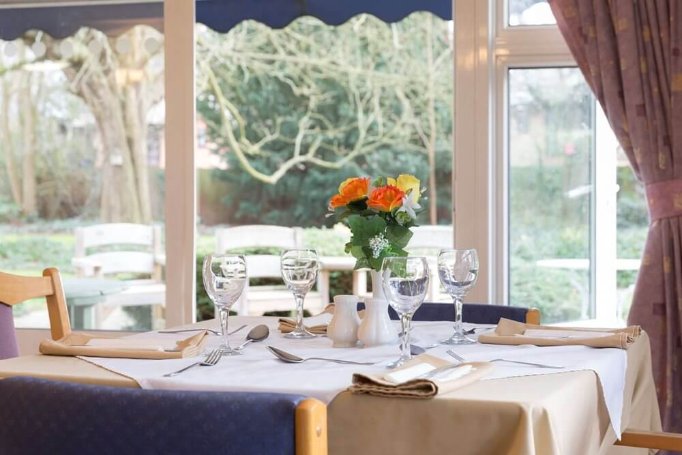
[{"x1": 438, "y1": 249, "x2": 478, "y2": 344}]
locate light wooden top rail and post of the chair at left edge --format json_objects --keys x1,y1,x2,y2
[{"x1": 0, "y1": 268, "x2": 71, "y2": 340}]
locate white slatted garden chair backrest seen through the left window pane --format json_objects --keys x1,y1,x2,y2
[{"x1": 72, "y1": 223, "x2": 163, "y2": 281}]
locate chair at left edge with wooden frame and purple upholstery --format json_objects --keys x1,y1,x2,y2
[{"x1": 0, "y1": 268, "x2": 71, "y2": 359}]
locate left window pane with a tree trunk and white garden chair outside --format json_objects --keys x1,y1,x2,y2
[{"x1": 0, "y1": 23, "x2": 165, "y2": 330}]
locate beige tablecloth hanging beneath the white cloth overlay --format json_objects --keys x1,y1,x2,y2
[{"x1": 0, "y1": 317, "x2": 660, "y2": 455}]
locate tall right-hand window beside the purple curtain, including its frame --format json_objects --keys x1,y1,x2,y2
[{"x1": 455, "y1": 0, "x2": 646, "y2": 324}]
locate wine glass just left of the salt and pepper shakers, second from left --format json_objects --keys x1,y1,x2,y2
[{"x1": 280, "y1": 250, "x2": 320, "y2": 339}]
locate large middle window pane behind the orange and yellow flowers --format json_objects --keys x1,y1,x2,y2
[{"x1": 196, "y1": 13, "x2": 453, "y2": 317}]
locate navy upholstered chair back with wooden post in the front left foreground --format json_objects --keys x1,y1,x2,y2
[{"x1": 0, "y1": 377, "x2": 327, "y2": 455}]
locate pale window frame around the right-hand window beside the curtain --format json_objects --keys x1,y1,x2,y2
[{"x1": 453, "y1": 0, "x2": 616, "y2": 323}]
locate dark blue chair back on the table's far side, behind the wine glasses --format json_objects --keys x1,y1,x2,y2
[{"x1": 388, "y1": 302, "x2": 540, "y2": 324}]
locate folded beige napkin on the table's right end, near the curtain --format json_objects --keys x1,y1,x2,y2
[{"x1": 478, "y1": 318, "x2": 642, "y2": 349}]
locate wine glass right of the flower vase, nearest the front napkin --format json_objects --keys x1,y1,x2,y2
[{"x1": 380, "y1": 257, "x2": 429, "y2": 368}]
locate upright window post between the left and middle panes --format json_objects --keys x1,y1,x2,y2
[{"x1": 13, "y1": 0, "x2": 196, "y2": 354}]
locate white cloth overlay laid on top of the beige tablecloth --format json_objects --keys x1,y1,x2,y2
[{"x1": 78, "y1": 317, "x2": 627, "y2": 437}]
